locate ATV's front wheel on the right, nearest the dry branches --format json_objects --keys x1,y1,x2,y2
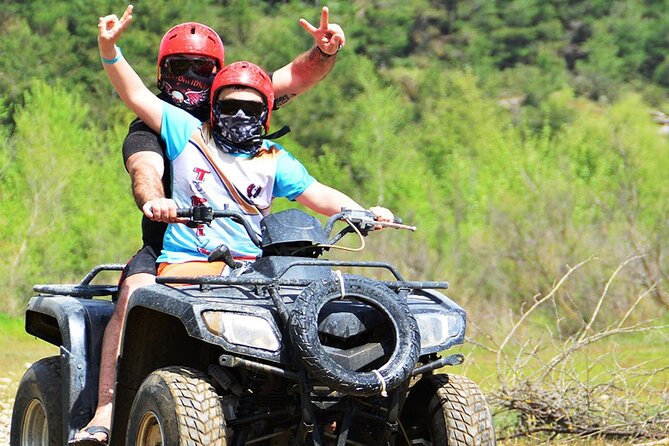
[{"x1": 399, "y1": 375, "x2": 496, "y2": 446}]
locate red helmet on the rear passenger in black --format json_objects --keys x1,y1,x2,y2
[{"x1": 158, "y1": 22, "x2": 225, "y2": 87}]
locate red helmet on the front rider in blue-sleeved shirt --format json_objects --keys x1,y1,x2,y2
[{"x1": 211, "y1": 62, "x2": 274, "y2": 132}]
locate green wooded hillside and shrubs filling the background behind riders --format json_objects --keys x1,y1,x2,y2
[{"x1": 0, "y1": 0, "x2": 669, "y2": 331}]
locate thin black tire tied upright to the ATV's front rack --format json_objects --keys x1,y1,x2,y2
[{"x1": 289, "y1": 275, "x2": 420, "y2": 396}]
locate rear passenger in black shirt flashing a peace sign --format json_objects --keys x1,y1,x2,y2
[{"x1": 71, "y1": 7, "x2": 345, "y2": 445}]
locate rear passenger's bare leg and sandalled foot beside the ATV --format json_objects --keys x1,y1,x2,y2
[{"x1": 74, "y1": 273, "x2": 155, "y2": 441}]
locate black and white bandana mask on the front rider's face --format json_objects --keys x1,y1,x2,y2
[{"x1": 212, "y1": 105, "x2": 267, "y2": 156}]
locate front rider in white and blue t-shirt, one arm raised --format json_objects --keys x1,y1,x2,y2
[{"x1": 98, "y1": 6, "x2": 393, "y2": 274}]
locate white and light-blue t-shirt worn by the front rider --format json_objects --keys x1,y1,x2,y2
[{"x1": 157, "y1": 103, "x2": 316, "y2": 263}]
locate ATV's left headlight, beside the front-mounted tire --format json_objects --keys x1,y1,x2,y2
[{"x1": 202, "y1": 311, "x2": 281, "y2": 352}]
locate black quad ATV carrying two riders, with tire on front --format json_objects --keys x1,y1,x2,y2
[{"x1": 11, "y1": 206, "x2": 495, "y2": 446}]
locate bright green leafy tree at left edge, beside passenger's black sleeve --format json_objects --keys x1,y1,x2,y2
[{"x1": 0, "y1": 81, "x2": 139, "y2": 312}]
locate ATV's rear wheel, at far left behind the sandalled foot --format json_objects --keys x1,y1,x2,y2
[{"x1": 10, "y1": 356, "x2": 64, "y2": 446}]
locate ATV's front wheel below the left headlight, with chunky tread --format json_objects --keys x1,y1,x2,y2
[{"x1": 126, "y1": 367, "x2": 227, "y2": 446}]
